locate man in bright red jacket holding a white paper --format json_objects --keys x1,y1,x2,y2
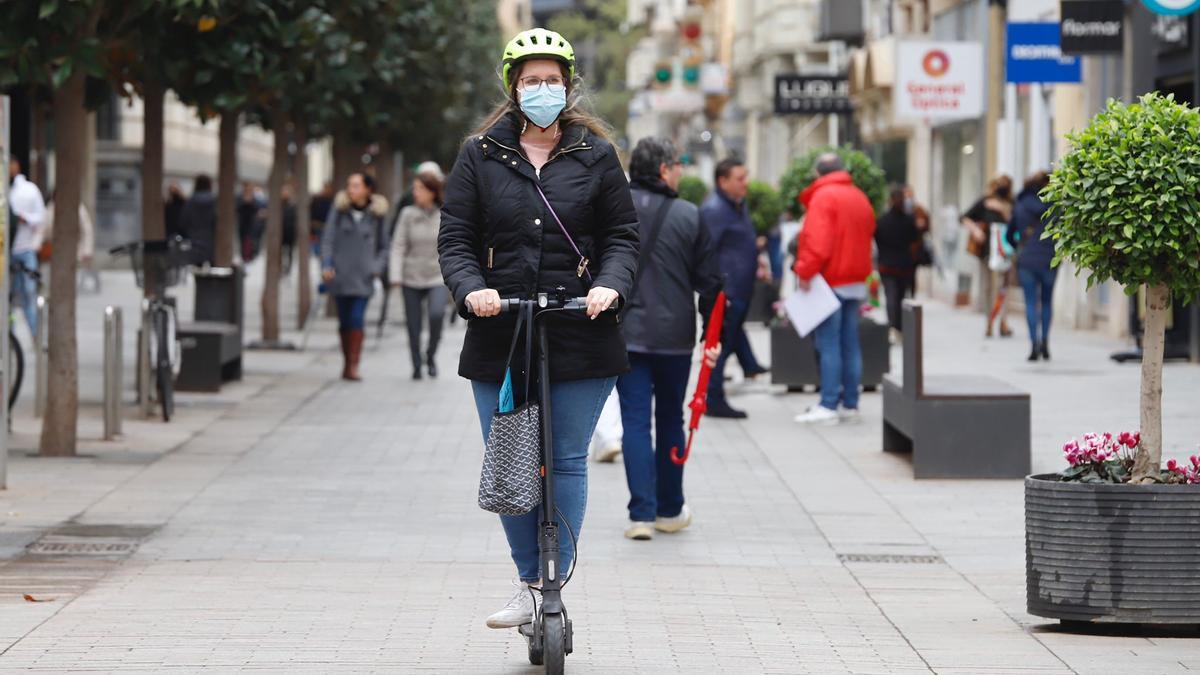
[{"x1": 796, "y1": 153, "x2": 875, "y2": 424}]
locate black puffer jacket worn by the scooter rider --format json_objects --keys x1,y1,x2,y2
[{"x1": 438, "y1": 117, "x2": 637, "y2": 382}]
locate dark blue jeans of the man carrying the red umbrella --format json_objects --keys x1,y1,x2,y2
[{"x1": 617, "y1": 352, "x2": 691, "y2": 522}]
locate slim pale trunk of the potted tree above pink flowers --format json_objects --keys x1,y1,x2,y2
[{"x1": 1130, "y1": 285, "x2": 1171, "y2": 483}]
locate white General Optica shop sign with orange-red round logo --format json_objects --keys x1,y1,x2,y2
[{"x1": 892, "y1": 42, "x2": 985, "y2": 121}]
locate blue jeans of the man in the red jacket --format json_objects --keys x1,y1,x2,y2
[{"x1": 812, "y1": 299, "x2": 863, "y2": 411}]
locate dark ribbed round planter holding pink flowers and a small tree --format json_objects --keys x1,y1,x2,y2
[{"x1": 1025, "y1": 474, "x2": 1200, "y2": 625}]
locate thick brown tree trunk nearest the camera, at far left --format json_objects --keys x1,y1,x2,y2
[{"x1": 38, "y1": 71, "x2": 88, "y2": 456}]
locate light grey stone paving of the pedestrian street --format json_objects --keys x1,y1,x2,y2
[{"x1": 0, "y1": 270, "x2": 1200, "y2": 674}]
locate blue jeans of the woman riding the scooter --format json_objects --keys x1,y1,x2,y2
[{"x1": 470, "y1": 377, "x2": 617, "y2": 581}]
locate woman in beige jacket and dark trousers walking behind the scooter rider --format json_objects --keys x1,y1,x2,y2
[{"x1": 389, "y1": 172, "x2": 449, "y2": 380}]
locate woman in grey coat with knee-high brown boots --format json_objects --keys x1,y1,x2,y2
[{"x1": 320, "y1": 173, "x2": 389, "y2": 381}]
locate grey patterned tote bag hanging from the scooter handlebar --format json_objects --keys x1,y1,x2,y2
[{"x1": 479, "y1": 300, "x2": 541, "y2": 515}]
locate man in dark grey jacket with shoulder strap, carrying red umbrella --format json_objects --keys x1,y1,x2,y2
[{"x1": 617, "y1": 138, "x2": 722, "y2": 539}]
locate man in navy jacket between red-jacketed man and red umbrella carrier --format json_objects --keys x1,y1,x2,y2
[{"x1": 700, "y1": 159, "x2": 767, "y2": 419}]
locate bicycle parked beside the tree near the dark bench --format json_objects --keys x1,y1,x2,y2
[{"x1": 109, "y1": 237, "x2": 191, "y2": 422}]
